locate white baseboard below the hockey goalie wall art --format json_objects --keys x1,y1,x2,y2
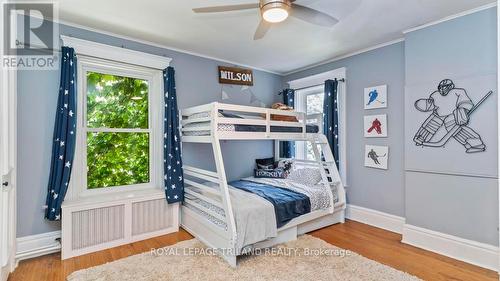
[{"x1": 402, "y1": 224, "x2": 499, "y2": 271}]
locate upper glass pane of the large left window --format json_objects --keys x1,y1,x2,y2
[{"x1": 87, "y1": 72, "x2": 149, "y2": 129}]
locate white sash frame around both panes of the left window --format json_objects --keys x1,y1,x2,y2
[{"x1": 72, "y1": 56, "x2": 163, "y2": 196}]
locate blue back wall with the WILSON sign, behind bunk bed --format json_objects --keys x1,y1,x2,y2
[{"x1": 17, "y1": 21, "x2": 281, "y2": 237}]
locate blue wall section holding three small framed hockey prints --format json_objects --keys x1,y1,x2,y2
[{"x1": 283, "y1": 42, "x2": 404, "y2": 216}]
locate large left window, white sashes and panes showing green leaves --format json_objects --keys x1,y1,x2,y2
[{"x1": 72, "y1": 56, "x2": 163, "y2": 195}]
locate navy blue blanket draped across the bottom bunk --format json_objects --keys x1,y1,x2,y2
[{"x1": 229, "y1": 180, "x2": 311, "y2": 228}]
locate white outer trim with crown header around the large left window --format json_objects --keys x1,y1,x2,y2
[{"x1": 60, "y1": 35, "x2": 172, "y2": 202}]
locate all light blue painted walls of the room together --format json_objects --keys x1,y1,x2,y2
[{"x1": 18, "y1": 9, "x2": 498, "y2": 245}]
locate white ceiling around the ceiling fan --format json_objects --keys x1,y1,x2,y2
[{"x1": 59, "y1": 0, "x2": 495, "y2": 73}]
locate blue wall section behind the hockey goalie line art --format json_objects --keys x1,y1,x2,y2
[{"x1": 404, "y1": 8, "x2": 498, "y2": 245}]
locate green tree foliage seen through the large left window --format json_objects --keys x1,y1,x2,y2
[{"x1": 86, "y1": 72, "x2": 150, "y2": 189}]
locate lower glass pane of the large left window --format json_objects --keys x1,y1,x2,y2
[{"x1": 87, "y1": 133, "x2": 149, "y2": 189}]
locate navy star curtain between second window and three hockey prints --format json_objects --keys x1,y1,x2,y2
[{"x1": 323, "y1": 79, "x2": 340, "y2": 168}]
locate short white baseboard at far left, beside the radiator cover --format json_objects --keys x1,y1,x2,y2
[{"x1": 16, "y1": 231, "x2": 61, "y2": 261}]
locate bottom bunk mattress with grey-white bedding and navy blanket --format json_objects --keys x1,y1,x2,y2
[{"x1": 184, "y1": 177, "x2": 338, "y2": 254}]
